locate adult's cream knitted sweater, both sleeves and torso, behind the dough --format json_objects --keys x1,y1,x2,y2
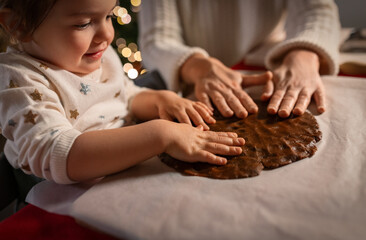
[{"x1": 139, "y1": 0, "x2": 340, "y2": 90}]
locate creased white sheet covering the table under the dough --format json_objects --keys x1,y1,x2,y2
[{"x1": 58, "y1": 77, "x2": 366, "y2": 240}]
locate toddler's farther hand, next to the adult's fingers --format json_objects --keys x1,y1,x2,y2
[{"x1": 156, "y1": 91, "x2": 216, "y2": 130}]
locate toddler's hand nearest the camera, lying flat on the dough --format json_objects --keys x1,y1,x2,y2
[{"x1": 165, "y1": 122, "x2": 245, "y2": 165}]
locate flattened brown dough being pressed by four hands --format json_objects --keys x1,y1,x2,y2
[{"x1": 160, "y1": 102, "x2": 322, "y2": 179}]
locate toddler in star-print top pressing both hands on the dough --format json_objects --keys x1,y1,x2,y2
[{"x1": 0, "y1": 0, "x2": 244, "y2": 183}]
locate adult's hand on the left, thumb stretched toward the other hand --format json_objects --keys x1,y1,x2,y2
[{"x1": 180, "y1": 54, "x2": 272, "y2": 118}]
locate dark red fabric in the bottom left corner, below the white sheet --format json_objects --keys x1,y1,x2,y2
[{"x1": 0, "y1": 204, "x2": 115, "y2": 240}]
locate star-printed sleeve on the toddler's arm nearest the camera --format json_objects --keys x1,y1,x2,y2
[{"x1": 0, "y1": 64, "x2": 81, "y2": 184}]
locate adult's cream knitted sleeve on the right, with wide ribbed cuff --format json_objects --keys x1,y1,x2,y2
[{"x1": 265, "y1": 0, "x2": 340, "y2": 75}]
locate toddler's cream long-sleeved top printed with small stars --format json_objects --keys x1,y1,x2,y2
[{"x1": 0, "y1": 47, "x2": 144, "y2": 184}]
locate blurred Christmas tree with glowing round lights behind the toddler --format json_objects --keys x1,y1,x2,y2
[{"x1": 112, "y1": 0, "x2": 146, "y2": 79}]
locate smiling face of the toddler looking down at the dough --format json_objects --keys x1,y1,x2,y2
[{"x1": 22, "y1": 0, "x2": 116, "y2": 75}]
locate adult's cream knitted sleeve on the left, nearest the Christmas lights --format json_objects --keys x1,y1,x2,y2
[{"x1": 139, "y1": 0, "x2": 208, "y2": 91}]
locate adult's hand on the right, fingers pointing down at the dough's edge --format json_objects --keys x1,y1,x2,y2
[{"x1": 262, "y1": 49, "x2": 325, "y2": 118}]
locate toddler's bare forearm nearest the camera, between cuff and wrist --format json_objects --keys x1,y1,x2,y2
[{"x1": 67, "y1": 120, "x2": 166, "y2": 181}]
